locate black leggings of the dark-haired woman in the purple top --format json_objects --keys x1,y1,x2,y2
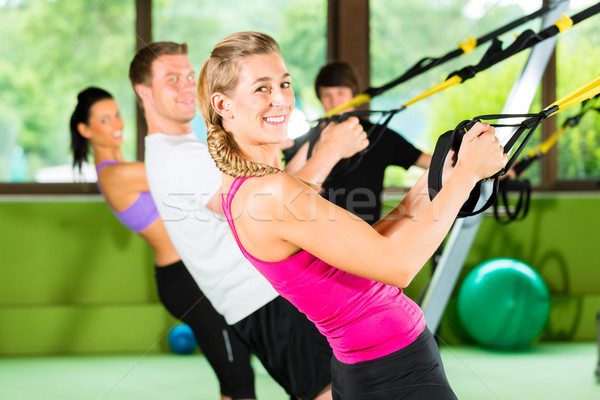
[{"x1": 155, "y1": 261, "x2": 256, "y2": 399}]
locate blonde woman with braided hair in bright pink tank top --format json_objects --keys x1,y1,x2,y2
[{"x1": 198, "y1": 32, "x2": 507, "y2": 400}]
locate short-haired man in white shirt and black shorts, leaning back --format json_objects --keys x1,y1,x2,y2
[{"x1": 130, "y1": 42, "x2": 368, "y2": 399}]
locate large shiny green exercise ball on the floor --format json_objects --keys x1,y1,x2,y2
[{"x1": 458, "y1": 258, "x2": 550, "y2": 350}]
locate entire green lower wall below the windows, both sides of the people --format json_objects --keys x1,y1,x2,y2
[{"x1": 0, "y1": 193, "x2": 600, "y2": 356}]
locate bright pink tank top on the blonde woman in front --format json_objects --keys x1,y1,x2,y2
[{"x1": 223, "y1": 178, "x2": 425, "y2": 364}]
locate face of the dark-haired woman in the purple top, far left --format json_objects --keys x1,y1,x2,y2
[{"x1": 79, "y1": 99, "x2": 124, "y2": 148}]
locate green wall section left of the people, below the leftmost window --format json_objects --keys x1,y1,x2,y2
[{"x1": 0, "y1": 196, "x2": 174, "y2": 356}]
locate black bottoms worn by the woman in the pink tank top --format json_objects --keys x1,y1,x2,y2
[{"x1": 331, "y1": 328, "x2": 456, "y2": 400}]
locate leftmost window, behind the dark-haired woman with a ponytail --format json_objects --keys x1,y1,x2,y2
[{"x1": 0, "y1": 0, "x2": 135, "y2": 183}]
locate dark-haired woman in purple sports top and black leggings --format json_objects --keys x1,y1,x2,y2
[{"x1": 70, "y1": 87, "x2": 256, "y2": 400}]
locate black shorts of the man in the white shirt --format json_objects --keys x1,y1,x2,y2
[{"x1": 232, "y1": 296, "x2": 332, "y2": 400}]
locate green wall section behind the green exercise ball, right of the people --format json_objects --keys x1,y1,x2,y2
[{"x1": 400, "y1": 193, "x2": 600, "y2": 344}]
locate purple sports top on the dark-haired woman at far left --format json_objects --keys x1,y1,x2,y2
[{"x1": 96, "y1": 160, "x2": 159, "y2": 233}]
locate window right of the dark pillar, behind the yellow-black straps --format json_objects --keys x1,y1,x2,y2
[{"x1": 370, "y1": 0, "x2": 600, "y2": 187}]
